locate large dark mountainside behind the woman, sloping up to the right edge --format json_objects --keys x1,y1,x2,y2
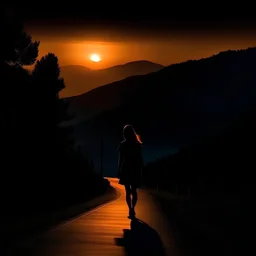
[{"x1": 62, "y1": 48, "x2": 256, "y2": 175}]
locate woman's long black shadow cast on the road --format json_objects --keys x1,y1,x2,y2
[{"x1": 116, "y1": 218, "x2": 166, "y2": 256}]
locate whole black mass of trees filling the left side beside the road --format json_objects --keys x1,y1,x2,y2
[{"x1": 0, "y1": 13, "x2": 109, "y2": 214}]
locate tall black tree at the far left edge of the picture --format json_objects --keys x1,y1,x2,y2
[{"x1": 0, "y1": 8, "x2": 39, "y2": 208}]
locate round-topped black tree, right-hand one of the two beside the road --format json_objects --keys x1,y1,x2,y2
[{"x1": 32, "y1": 53, "x2": 100, "y2": 200}]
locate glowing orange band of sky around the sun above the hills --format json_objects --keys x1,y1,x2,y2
[{"x1": 26, "y1": 27, "x2": 256, "y2": 69}]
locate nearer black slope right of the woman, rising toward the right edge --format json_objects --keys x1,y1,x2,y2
[{"x1": 144, "y1": 102, "x2": 256, "y2": 197}]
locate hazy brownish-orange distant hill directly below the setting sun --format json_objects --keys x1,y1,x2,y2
[{"x1": 60, "y1": 60, "x2": 164, "y2": 98}]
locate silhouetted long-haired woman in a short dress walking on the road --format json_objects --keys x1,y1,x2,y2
[{"x1": 118, "y1": 125, "x2": 143, "y2": 218}]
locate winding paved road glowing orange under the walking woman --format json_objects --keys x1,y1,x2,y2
[{"x1": 7, "y1": 178, "x2": 179, "y2": 256}]
